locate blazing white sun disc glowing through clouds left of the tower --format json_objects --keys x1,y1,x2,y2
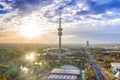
[{"x1": 19, "y1": 23, "x2": 42, "y2": 38}]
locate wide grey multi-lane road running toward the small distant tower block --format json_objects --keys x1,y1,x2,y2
[{"x1": 86, "y1": 51, "x2": 107, "y2": 80}]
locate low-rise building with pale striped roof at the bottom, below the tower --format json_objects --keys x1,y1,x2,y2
[{"x1": 48, "y1": 65, "x2": 80, "y2": 80}]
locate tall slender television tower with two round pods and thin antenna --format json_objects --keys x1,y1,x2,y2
[{"x1": 58, "y1": 9, "x2": 63, "y2": 60}]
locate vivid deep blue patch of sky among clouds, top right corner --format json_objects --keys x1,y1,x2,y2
[{"x1": 77, "y1": 0, "x2": 120, "y2": 15}]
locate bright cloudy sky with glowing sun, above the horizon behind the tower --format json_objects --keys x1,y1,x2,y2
[{"x1": 0, "y1": 0, "x2": 120, "y2": 44}]
